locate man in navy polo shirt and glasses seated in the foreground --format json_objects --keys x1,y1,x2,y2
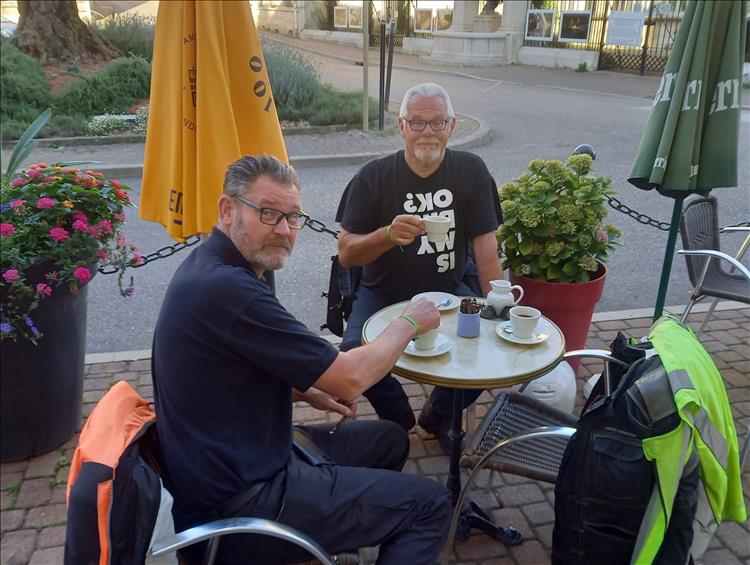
[{"x1": 152, "y1": 157, "x2": 451, "y2": 565}]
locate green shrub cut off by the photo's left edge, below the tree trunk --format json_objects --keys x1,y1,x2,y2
[{"x1": 0, "y1": 39, "x2": 51, "y2": 134}]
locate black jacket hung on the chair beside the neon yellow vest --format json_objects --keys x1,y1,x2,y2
[{"x1": 552, "y1": 335, "x2": 699, "y2": 565}]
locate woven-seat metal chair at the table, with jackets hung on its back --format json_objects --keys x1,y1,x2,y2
[{"x1": 444, "y1": 349, "x2": 628, "y2": 551}]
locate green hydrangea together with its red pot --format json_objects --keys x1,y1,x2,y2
[{"x1": 497, "y1": 155, "x2": 621, "y2": 366}]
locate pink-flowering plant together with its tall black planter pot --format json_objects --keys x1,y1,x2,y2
[{"x1": 0, "y1": 112, "x2": 142, "y2": 461}]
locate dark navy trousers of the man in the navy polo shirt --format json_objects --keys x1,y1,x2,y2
[{"x1": 210, "y1": 420, "x2": 452, "y2": 565}]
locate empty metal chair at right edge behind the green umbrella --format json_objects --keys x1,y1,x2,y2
[{"x1": 678, "y1": 196, "x2": 750, "y2": 335}]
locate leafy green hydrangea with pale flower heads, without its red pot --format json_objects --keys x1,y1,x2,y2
[{"x1": 497, "y1": 155, "x2": 622, "y2": 283}]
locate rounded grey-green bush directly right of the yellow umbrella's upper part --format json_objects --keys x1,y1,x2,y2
[{"x1": 263, "y1": 41, "x2": 322, "y2": 115}]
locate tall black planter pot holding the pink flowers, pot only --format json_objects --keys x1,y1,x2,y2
[{"x1": 0, "y1": 264, "x2": 90, "y2": 462}]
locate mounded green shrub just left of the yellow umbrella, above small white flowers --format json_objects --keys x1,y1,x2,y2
[{"x1": 56, "y1": 57, "x2": 151, "y2": 116}]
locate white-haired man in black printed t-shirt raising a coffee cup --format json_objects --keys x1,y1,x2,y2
[{"x1": 336, "y1": 83, "x2": 503, "y2": 453}]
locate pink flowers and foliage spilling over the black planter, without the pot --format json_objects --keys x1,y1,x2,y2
[{"x1": 0, "y1": 163, "x2": 143, "y2": 343}]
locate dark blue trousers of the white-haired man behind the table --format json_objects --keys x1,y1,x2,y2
[{"x1": 340, "y1": 283, "x2": 482, "y2": 422}]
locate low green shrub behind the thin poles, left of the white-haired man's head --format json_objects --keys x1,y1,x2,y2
[{"x1": 288, "y1": 85, "x2": 378, "y2": 126}]
